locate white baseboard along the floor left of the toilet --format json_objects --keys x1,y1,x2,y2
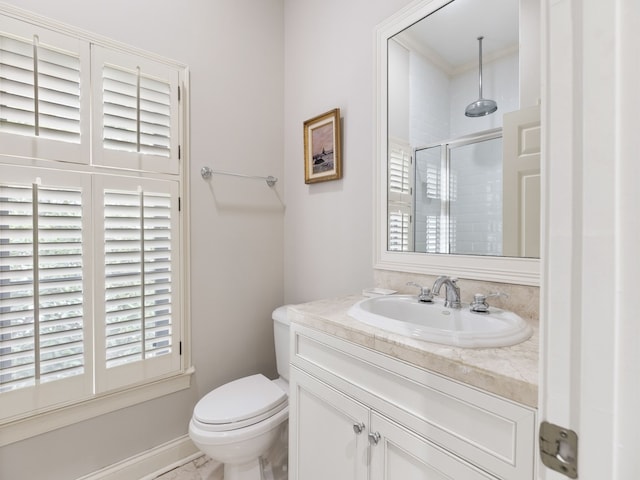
[{"x1": 77, "y1": 435, "x2": 212, "y2": 480}]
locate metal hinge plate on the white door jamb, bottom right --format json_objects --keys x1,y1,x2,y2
[{"x1": 539, "y1": 422, "x2": 578, "y2": 478}]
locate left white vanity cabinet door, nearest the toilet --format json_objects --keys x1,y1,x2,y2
[{"x1": 289, "y1": 367, "x2": 369, "y2": 480}]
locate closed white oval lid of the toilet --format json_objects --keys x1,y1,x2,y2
[{"x1": 193, "y1": 374, "x2": 287, "y2": 430}]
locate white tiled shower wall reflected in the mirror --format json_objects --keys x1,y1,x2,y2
[{"x1": 410, "y1": 43, "x2": 519, "y2": 255}]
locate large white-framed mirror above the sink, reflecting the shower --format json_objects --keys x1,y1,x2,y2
[{"x1": 376, "y1": 0, "x2": 540, "y2": 285}]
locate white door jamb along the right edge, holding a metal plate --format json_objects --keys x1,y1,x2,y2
[{"x1": 538, "y1": 0, "x2": 640, "y2": 480}]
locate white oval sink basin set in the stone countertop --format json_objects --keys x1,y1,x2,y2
[{"x1": 348, "y1": 295, "x2": 533, "y2": 348}]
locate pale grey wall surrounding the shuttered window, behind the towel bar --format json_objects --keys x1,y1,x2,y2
[{"x1": 0, "y1": 0, "x2": 284, "y2": 480}]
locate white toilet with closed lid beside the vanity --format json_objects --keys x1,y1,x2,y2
[{"x1": 189, "y1": 306, "x2": 289, "y2": 480}]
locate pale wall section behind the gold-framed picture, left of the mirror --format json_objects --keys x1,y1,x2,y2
[{"x1": 284, "y1": 0, "x2": 409, "y2": 302}]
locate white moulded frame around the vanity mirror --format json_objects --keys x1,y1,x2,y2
[{"x1": 374, "y1": 0, "x2": 540, "y2": 286}]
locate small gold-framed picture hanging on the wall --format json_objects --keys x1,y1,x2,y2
[{"x1": 304, "y1": 108, "x2": 342, "y2": 183}]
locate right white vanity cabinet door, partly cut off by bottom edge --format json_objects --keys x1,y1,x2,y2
[{"x1": 370, "y1": 412, "x2": 496, "y2": 480}]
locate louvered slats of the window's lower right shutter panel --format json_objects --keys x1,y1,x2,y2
[{"x1": 104, "y1": 189, "x2": 175, "y2": 369}]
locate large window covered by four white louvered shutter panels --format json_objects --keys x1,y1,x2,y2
[{"x1": 0, "y1": 11, "x2": 189, "y2": 436}]
